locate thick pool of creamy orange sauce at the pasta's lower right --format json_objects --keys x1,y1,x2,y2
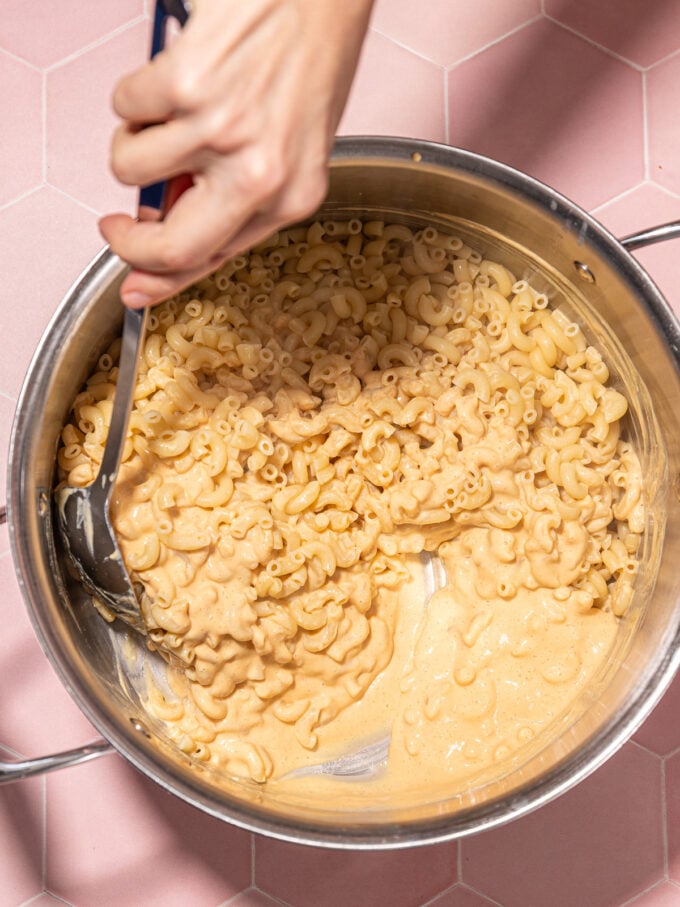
[{"x1": 390, "y1": 530, "x2": 616, "y2": 784}]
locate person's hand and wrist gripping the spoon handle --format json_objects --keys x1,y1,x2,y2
[{"x1": 100, "y1": 0, "x2": 373, "y2": 308}]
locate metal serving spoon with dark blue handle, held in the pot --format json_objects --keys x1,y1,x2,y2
[{"x1": 56, "y1": 0, "x2": 187, "y2": 633}]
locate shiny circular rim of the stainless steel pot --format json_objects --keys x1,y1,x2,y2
[{"x1": 7, "y1": 136, "x2": 680, "y2": 849}]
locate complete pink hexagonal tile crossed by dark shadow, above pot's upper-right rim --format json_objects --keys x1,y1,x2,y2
[{"x1": 440, "y1": 19, "x2": 644, "y2": 208}]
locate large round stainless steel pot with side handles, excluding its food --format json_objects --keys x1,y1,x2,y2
[{"x1": 5, "y1": 138, "x2": 680, "y2": 848}]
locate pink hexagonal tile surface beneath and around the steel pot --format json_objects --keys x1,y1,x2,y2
[{"x1": 0, "y1": 0, "x2": 680, "y2": 907}]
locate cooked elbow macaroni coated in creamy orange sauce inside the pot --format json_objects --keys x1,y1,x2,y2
[{"x1": 58, "y1": 219, "x2": 645, "y2": 782}]
